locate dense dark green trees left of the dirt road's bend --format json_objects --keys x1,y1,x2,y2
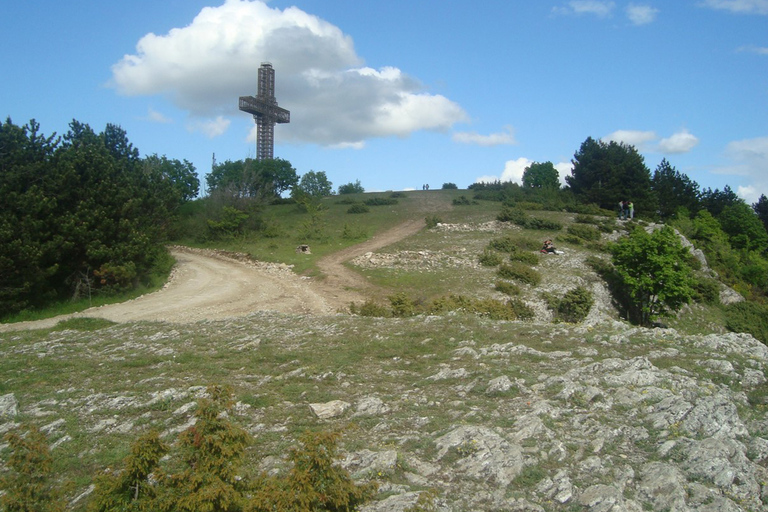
[{"x1": 0, "y1": 119, "x2": 199, "y2": 313}]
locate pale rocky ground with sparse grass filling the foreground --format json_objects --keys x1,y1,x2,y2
[{"x1": 0, "y1": 221, "x2": 768, "y2": 512}]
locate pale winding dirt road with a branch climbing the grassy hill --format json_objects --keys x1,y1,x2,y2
[{"x1": 0, "y1": 219, "x2": 432, "y2": 332}]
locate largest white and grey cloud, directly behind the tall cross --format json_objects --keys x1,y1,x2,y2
[{"x1": 110, "y1": 0, "x2": 467, "y2": 147}]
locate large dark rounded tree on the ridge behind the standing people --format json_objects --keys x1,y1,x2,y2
[{"x1": 565, "y1": 137, "x2": 656, "y2": 214}]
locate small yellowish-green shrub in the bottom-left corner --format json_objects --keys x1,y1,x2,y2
[{"x1": 0, "y1": 426, "x2": 66, "y2": 512}]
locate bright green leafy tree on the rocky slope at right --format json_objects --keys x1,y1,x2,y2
[{"x1": 611, "y1": 226, "x2": 693, "y2": 325}]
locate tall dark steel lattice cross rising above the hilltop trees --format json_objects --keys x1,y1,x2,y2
[{"x1": 240, "y1": 62, "x2": 291, "y2": 160}]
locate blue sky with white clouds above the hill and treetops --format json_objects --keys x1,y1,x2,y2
[{"x1": 0, "y1": 0, "x2": 768, "y2": 202}]
